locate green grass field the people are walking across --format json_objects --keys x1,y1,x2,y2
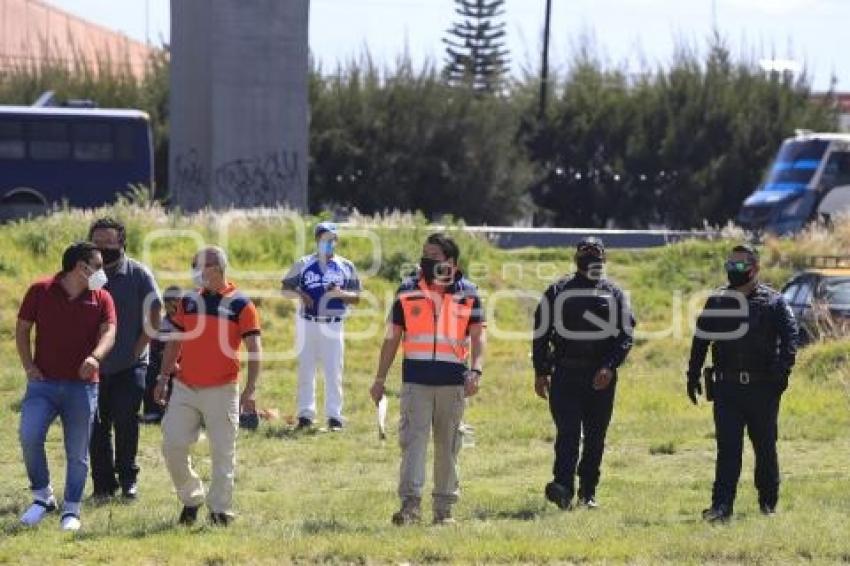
[{"x1": 0, "y1": 206, "x2": 850, "y2": 564}]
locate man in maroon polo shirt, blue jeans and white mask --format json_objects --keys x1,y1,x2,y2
[{"x1": 15, "y1": 242, "x2": 116, "y2": 531}]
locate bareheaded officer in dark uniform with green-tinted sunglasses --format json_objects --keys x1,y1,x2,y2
[{"x1": 687, "y1": 245, "x2": 797, "y2": 522}]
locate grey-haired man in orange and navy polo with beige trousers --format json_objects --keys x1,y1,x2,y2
[{"x1": 154, "y1": 247, "x2": 261, "y2": 527}]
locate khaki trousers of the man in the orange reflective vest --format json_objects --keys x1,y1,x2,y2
[{"x1": 398, "y1": 383, "x2": 465, "y2": 509}]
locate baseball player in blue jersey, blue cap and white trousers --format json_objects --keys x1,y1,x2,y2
[{"x1": 282, "y1": 222, "x2": 360, "y2": 431}]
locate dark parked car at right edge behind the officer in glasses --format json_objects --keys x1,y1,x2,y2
[{"x1": 782, "y1": 256, "x2": 850, "y2": 344}]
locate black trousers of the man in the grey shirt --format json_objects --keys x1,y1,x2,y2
[{"x1": 90, "y1": 364, "x2": 147, "y2": 494}]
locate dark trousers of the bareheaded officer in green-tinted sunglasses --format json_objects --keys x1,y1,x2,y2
[{"x1": 712, "y1": 382, "x2": 781, "y2": 508}]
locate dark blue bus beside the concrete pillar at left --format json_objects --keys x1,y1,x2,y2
[{"x1": 0, "y1": 106, "x2": 154, "y2": 219}]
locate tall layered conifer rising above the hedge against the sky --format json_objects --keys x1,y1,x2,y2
[{"x1": 443, "y1": 0, "x2": 509, "y2": 93}]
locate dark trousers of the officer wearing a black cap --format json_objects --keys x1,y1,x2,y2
[{"x1": 549, "y1": 368, "x2": 617, "y2": 496}]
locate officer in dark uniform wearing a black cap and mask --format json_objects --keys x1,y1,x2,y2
[{"x1": 532, "y1": 237, "x2": 635, "y2": 509}]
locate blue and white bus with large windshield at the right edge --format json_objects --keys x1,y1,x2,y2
[{"x1": 738, "y1": 131, "x2": 850, "y2": 235}]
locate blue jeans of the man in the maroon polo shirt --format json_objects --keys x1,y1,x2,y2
[{"x1": 20, "y1": 379, "x2": 98, "y2": 503}]
